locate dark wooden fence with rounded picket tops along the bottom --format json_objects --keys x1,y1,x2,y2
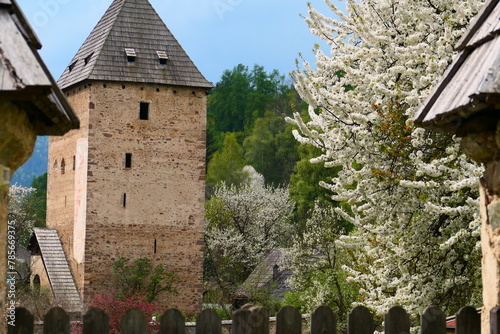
[{"x1": 8, "y1": 306, "x2": 500, "y2": 334}]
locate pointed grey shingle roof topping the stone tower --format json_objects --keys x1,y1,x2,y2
[{"x1": 58, "y1": 0, "x2": 212, "y2": 89}]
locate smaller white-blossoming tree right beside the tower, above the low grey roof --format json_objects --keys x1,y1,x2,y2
[{"x1": 205, "y1": 166, "x2": 294, "y2": 280}]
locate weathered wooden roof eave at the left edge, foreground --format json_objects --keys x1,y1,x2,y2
[{"x1": 0, "y1": 0, "x2": 80, "y2": 135}]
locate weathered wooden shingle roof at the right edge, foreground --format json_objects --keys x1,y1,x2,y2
[{"x1": 415, "y1": 0, "x2": 500, "y2": 136}]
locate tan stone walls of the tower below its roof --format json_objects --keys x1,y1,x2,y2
[{"x1": 47, "y1": 82, "x2": 206, "y2": 313}]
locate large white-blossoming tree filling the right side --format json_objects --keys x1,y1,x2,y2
[{"x1": 289, "y1": 0, "x2": 482, "y2": 314}]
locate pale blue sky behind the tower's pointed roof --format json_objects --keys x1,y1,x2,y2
[{"x1": 18, "y1": 0, "x2": 343, "y2": 83}]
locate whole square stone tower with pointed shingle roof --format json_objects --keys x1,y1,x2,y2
[{"x1": 47, "y1": 0, "x2": 212, "y2": 313}]
